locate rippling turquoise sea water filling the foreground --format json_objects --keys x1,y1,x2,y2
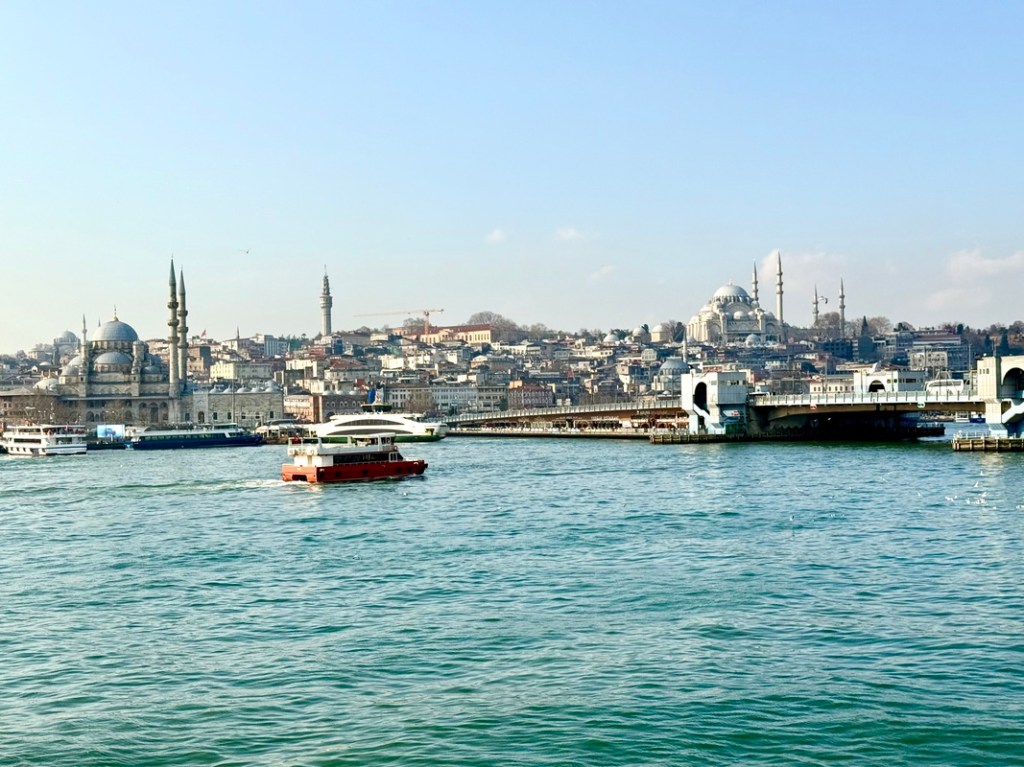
[{"x1": 0, "y1": 438, "x2": 1024, "y2": 766}]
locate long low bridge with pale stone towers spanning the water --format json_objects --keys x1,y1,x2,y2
[{"x1": 446, "y1": 356, "x2": 1024, "y2": 438}]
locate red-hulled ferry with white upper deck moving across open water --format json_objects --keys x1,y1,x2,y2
[{"x1": 281, "y1": 433, "x2": 427, "y2": 482}]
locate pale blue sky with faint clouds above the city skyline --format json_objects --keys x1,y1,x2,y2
[{"x1": 0, "y1": 0, "x2": 1024, "y2": 353}]
